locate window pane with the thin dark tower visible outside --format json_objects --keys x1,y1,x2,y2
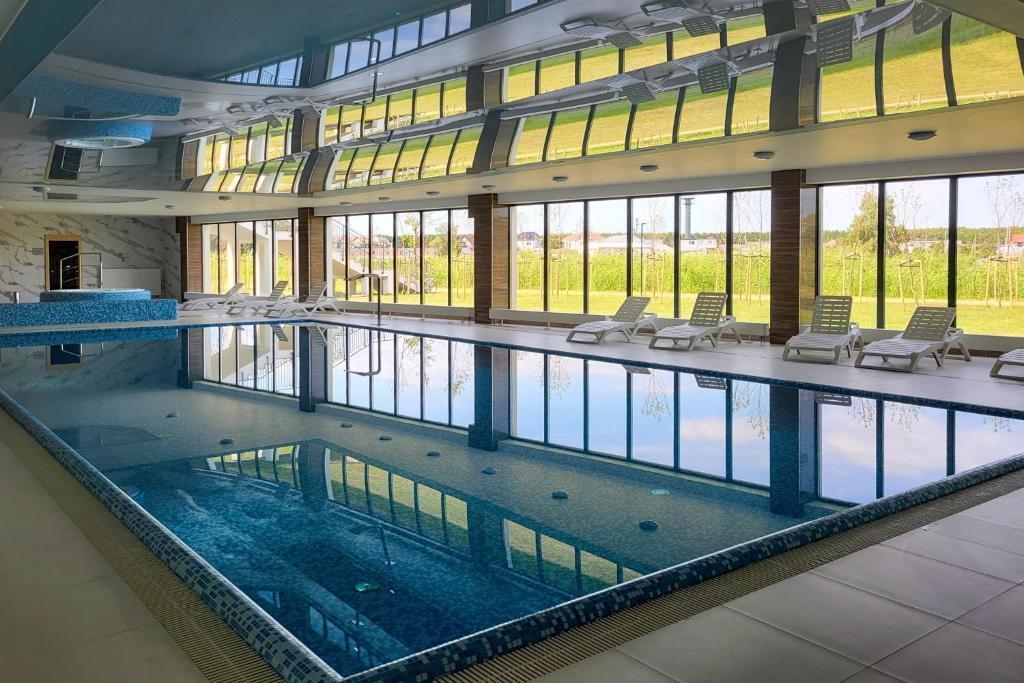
[{"x1": 677, "y1": 193, "x2": 728, "y2": 317}]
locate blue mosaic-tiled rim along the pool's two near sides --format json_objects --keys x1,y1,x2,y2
[{"x1": 0, "y1": 378, "x2": 1024, "y2": 683}]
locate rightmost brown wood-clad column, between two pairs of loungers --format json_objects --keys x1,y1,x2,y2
[{"x1": 769, "y1": 170, "x2": 817, "y2": 344}]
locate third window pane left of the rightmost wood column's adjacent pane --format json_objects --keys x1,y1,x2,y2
[{"x1": 587, "y1": 200, "x2": 628, "y2": 314}]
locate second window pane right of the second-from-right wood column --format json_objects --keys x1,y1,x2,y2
[{"x1": 548, "y1": 202, "x2": 584, "y2": 313}]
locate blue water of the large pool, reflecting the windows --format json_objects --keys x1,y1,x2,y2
[{"x1": 0, "y1": 325, "x2": 1024, "y2": 676}]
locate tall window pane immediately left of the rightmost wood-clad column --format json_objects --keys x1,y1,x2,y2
[{"x1": 732, "y1": 189, "x2": 771, "y2": 323}]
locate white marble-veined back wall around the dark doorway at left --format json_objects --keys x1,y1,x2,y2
[{"x1": 0, "y1": 212, "x2": 180, "y2": 303}]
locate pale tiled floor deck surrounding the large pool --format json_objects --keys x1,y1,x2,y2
[{"x1": 0, "y1": 315, "x2": 1024, "y2": 681}]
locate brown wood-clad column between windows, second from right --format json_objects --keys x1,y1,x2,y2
[{"x1": 469, "y1": 195, "x2": 509, "y2": 324}]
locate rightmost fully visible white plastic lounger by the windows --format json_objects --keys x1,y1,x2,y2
[{"x1": 854, "y1": 306, "x2": 962, "y2": 373}]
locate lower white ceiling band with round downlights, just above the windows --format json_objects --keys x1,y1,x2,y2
[{"x1": 0, "y1": 98, "x2": 1024, "y2": 216}]
